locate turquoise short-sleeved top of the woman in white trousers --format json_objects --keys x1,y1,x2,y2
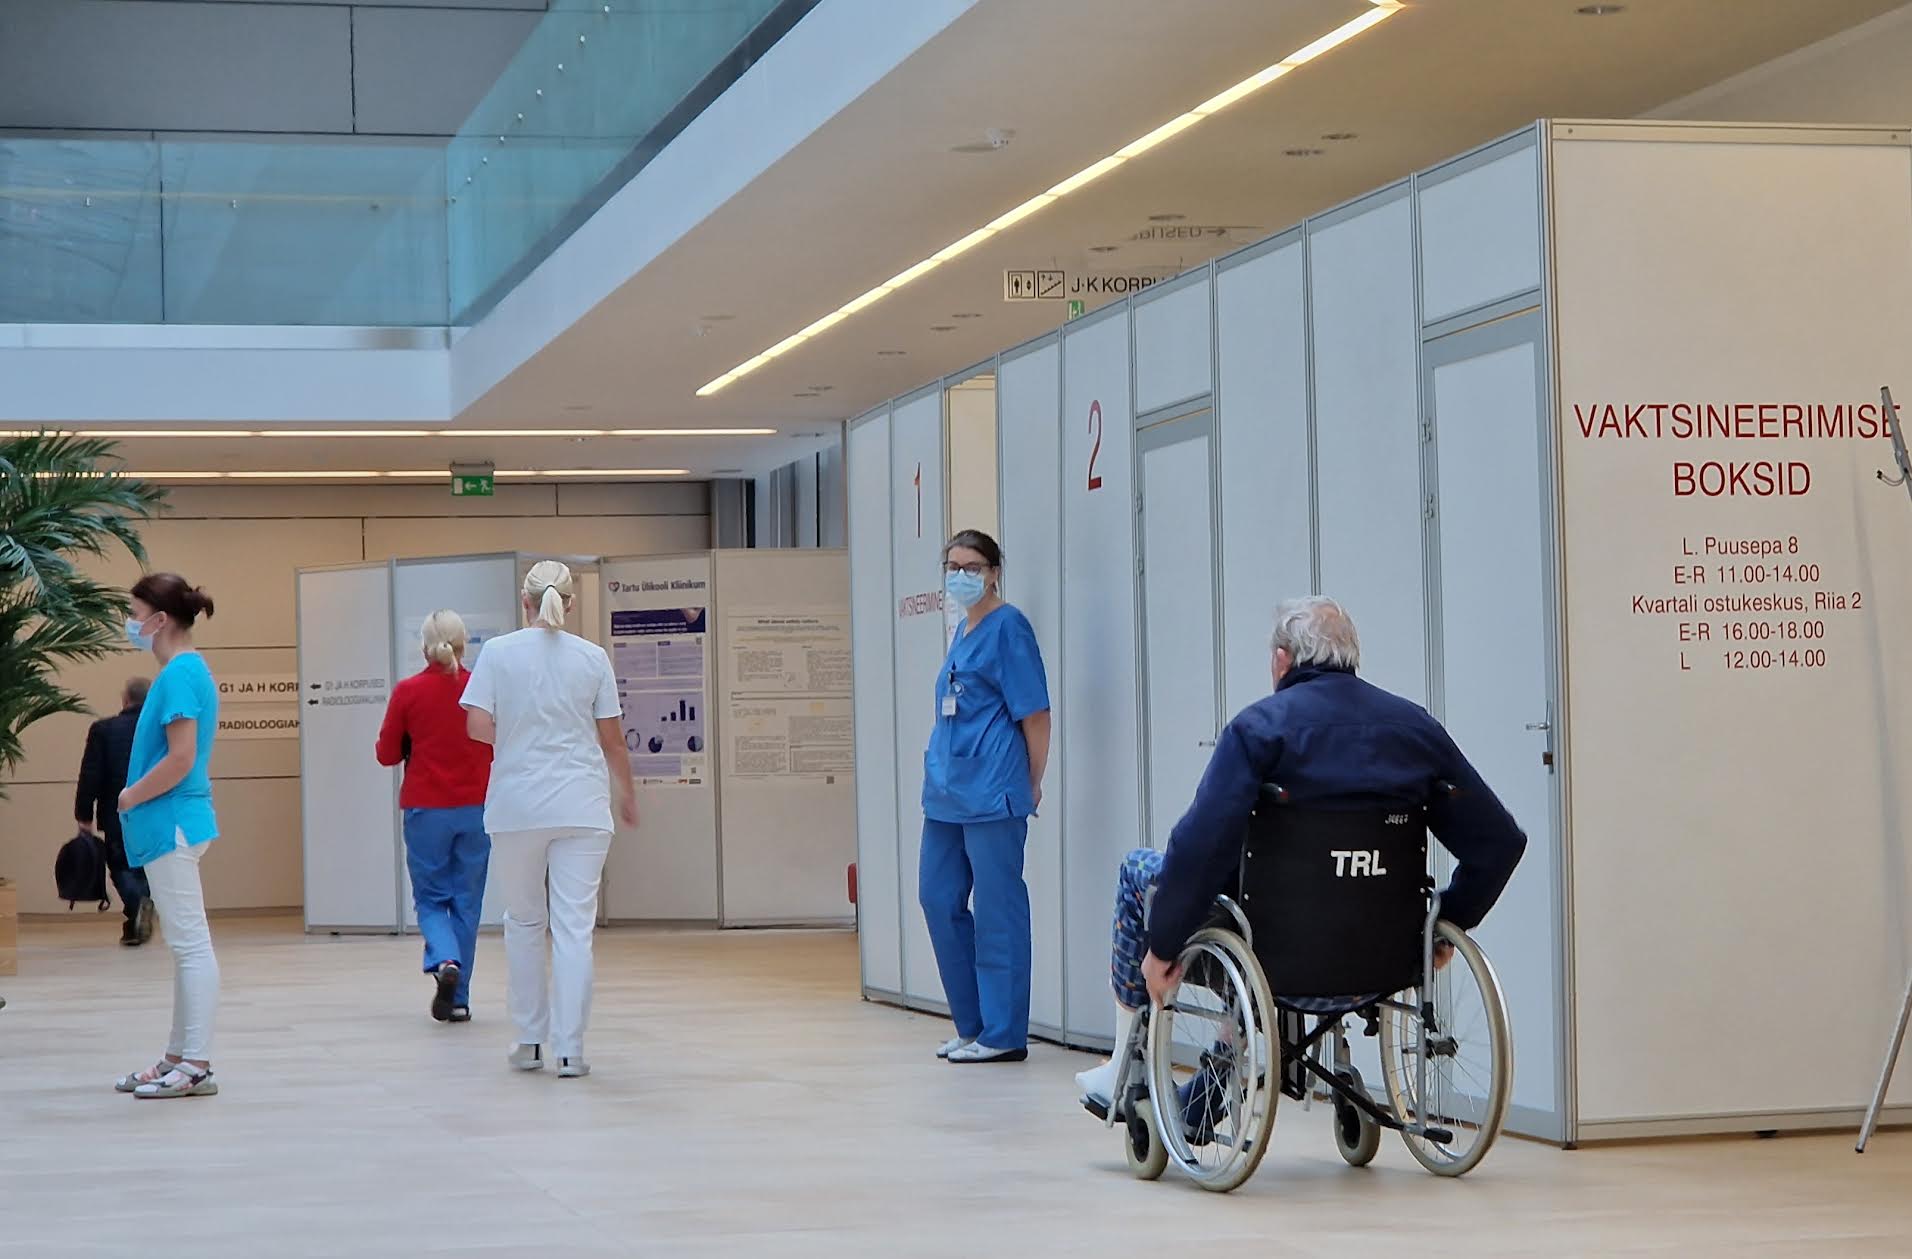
[{"x1": 120, "y1": 651, "x2": 220, "y2": 867}]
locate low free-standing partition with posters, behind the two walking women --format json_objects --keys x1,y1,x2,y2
[{"x1": 296, "y1": 551, "x2": 855, "y2": 932}]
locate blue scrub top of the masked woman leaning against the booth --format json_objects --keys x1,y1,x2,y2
[{"x1": 923, "y1": 605, "x2": 1050, "y2": 823}]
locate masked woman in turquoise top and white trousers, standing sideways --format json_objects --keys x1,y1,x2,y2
[{"x1": 115, "y1": 572, "x2": 220, "y2": 1098}]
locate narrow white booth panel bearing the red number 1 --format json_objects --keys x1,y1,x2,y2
[{"x1": 889, "y1": 388, "x2": 948, "y2": 1006}]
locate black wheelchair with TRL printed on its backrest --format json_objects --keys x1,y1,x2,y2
[{"x1": 1090, "y1": 784, "x2": 1514, "y2": 1192}]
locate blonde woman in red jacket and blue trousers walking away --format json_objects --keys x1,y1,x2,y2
[{"x1": 379, "y1": 612, "x2": 491, "y2": 1024}]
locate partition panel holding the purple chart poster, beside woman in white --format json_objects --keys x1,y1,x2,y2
[{"x1": 598, "y1": 551, "x2": 719, "y2": 922}]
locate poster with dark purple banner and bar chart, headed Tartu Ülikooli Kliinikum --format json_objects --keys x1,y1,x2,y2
[{"x1": 604, "y1": 557, "x2": 709, "y2": 786}]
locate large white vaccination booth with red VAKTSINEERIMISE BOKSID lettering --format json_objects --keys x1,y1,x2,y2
[{"x1": 847, "y1": 122, "x2": 1912, "y2": 1144}]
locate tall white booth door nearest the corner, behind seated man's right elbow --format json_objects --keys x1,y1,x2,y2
[{"x1": 1424, "y1": 312, "x2": 1564, "y2": 1140}]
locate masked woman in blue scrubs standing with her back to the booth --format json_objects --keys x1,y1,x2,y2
[{"x1": 918, "y1": 530, "x2": 1050, "y2": 1062}]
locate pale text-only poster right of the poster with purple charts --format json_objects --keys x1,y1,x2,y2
[{"x1": 725, "y1": 608, "x2": 855, "y2": 783}]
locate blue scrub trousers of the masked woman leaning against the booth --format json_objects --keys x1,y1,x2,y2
[{"x1": 916, "y1": 817, "x2": 1029, "y2": 1049}]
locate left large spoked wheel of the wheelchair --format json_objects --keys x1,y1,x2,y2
[{"x1": 1149, "y1": 928, "x2": 1281, "y2": 1192}]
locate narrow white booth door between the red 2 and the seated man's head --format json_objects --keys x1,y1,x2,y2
[{"x1": 1136, "y1": 408, "x2": 1222, "y2": 848}]
